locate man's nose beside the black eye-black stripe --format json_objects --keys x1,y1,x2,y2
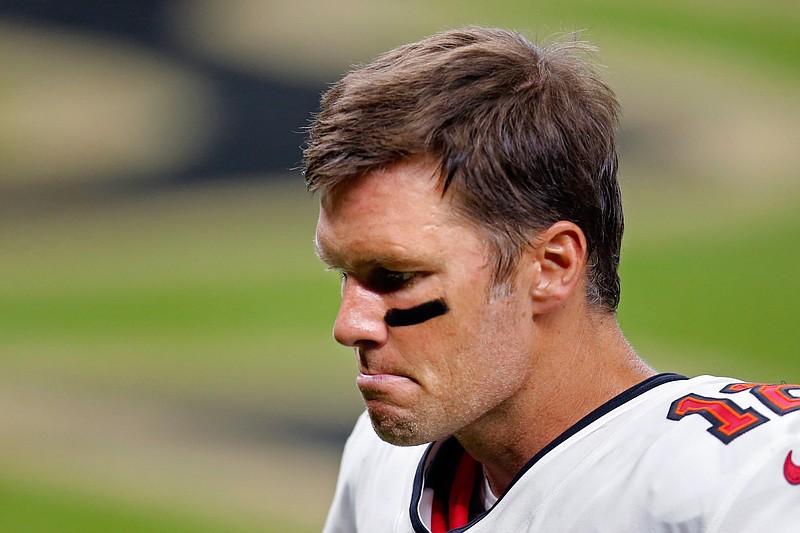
[{"x1": 333, "y1": 278, "x2": 388, "y2": 347}]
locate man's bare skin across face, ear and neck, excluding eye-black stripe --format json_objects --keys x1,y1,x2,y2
[{"x1": 316, "y1": 159, "x2": 652, "y2": 494}]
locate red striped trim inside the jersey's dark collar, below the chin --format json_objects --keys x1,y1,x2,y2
[{"x1": 431, "y1": 452, "x2": 480, "y2": 533}]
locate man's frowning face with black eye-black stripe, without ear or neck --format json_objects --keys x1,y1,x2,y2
[{"x1": 317, "y1": 161, "x2": 533, "y2": 445}]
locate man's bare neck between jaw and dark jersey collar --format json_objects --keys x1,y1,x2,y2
[{"x1": 456, "y1": 306, "x2": 654, "y2": 496}]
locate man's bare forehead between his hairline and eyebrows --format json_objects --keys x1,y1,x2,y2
[{"x1": 310, "y1": 160, "x2": 472, "y2": 267}]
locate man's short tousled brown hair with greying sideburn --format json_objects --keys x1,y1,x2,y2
[{"x1": 303, "y1": 27, "x2": 623, "y2": 312}]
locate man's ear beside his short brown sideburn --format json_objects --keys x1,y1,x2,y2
[{"x1": 531, "y1": 220, "x2": 587, "y2": 314}]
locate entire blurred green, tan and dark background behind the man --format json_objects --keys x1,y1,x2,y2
[{"x1": 0, "y1": 0, "x2": 800, "y2": 532}]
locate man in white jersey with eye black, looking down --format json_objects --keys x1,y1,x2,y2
[{"x1": 305, "y1": 28, "x2": 800, "y2": 533}]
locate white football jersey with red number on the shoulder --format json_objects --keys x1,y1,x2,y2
[{"x1": 323, "y1": 374, "x2": 800, "y2": 533}]
